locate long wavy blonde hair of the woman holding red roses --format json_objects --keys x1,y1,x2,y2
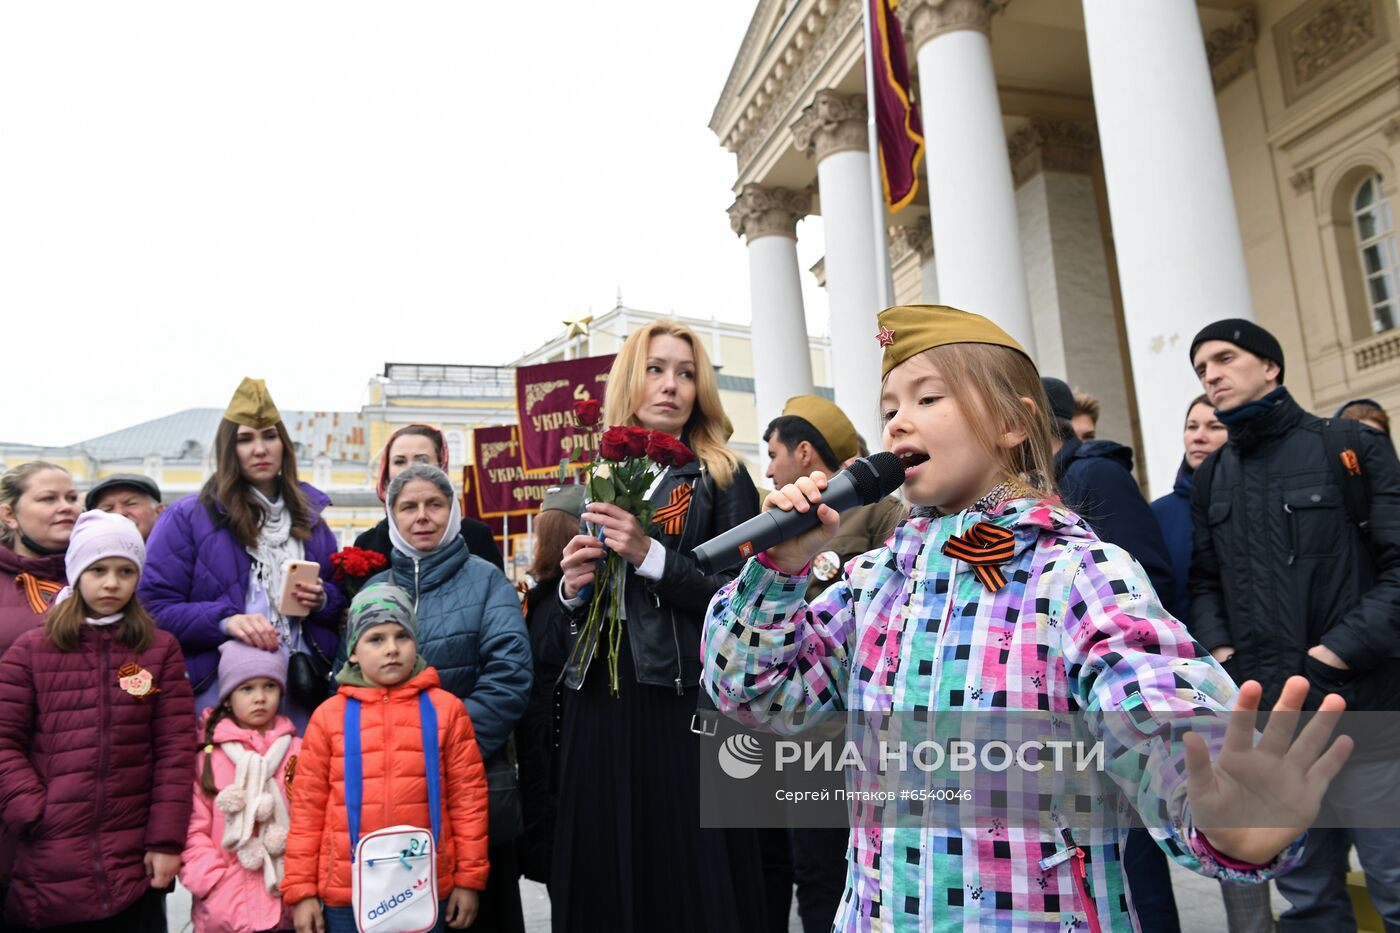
[{"x1": 603, "y1": 321, "x2": 741, "y2": 489}]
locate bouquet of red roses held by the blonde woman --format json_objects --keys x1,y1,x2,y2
[{"x1": 570, "y1": 402, "x2": 696, "y2": 696}]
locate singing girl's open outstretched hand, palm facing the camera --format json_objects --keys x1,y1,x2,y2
[{"x1": 1186, "y1": 677, "x2": 1352, "y2": 864}]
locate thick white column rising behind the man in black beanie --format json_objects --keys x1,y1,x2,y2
[{"x1": 1084, "y1": 0, "x2": 1254, "y2": 496}]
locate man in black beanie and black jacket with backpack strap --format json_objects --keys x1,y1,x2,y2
[{"x1": 1189, "y1": 319, "x2": 1400, "y2": 930}]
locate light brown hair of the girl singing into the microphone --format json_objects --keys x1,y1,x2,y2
[{"x1": 896, "y1": 343, "x2": 1057, "y2": 499}]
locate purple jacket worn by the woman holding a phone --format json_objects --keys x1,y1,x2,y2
[{"x1": 139, "y1": 483, "x2": 346, "y2": 693}]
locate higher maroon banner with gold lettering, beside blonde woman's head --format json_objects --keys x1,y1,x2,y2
[{"x1": 515, "y1": 354, "x2": 613, "y2": 475}]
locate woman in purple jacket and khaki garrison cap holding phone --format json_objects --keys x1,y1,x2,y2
[{"x1": 140, "y1": 378, "x2": 344, "y2": 731}]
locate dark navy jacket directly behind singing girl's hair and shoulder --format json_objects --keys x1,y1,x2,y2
[{"x1": 1054, "y1": 437, "x2": 1176, "y2": 605}]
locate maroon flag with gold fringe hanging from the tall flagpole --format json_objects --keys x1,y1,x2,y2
[{"x1": 867, "y1": 0, "x2": 924, "y2": 213}]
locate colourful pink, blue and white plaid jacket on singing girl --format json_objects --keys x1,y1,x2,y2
[{"x1": 703, "y1": 499, "x2": 1302, "y2": 933}]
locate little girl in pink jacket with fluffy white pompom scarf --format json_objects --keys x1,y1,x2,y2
[{"x1": 179, "y1": 639, "x2": 301, "y2": 933}]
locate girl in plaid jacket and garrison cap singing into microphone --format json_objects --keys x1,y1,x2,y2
[{"x1": 703, "y1": 305, "x2": 1351, "y2": 933}]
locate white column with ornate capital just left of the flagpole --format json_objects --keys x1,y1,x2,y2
[{"x1": 792, "y1": 91, "x2": 888, "y2": 448}]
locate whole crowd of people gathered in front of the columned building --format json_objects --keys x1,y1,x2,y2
[{"x1": 0, "y1": 305, "x2": 1400, "y2": 933}]
